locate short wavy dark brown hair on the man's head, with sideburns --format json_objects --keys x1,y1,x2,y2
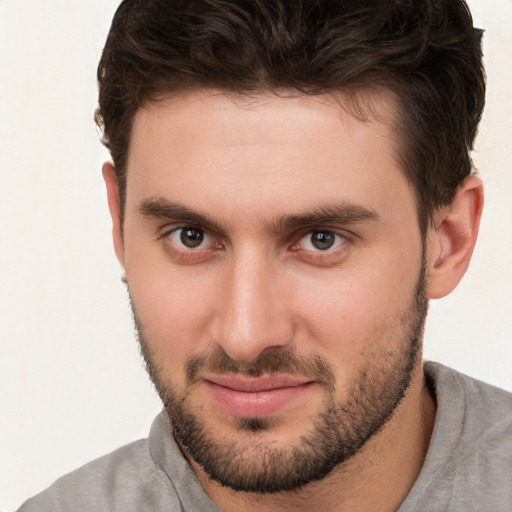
[{"x1": 96, "y1": 0, "x2": 485, "y2": 232}]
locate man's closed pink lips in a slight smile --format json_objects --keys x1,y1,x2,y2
[{"x1": 203, "y1": 375, "x2": 314, "y2": 418}]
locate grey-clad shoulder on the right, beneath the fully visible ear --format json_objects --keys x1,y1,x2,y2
[{"x1": 400, "y1": 363, "x2": 512, "y2": 512}]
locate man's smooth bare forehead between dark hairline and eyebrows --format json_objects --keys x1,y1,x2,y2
[{"x1": 127, "y1": 90, "x2": 411, "y2": 230}]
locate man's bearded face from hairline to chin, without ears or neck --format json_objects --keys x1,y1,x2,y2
[{"x1": 116, "y1": 91, "x2": 426, "y2": 492}]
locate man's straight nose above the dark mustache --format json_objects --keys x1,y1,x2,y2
[{"x1": 210, "y1": 247, "x2": 294, "y2": 361}]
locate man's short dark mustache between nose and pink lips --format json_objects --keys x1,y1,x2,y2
[{"x1": 185, "y1": 347, "x2": 335, "y2": 388}]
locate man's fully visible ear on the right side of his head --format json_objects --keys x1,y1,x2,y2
[{"x1": 427, "y1": 176, "x2": 484, "y2": 299}]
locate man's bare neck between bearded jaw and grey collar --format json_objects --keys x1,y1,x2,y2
[{"x1": 191, "y1": 365, "x2": 435, "y2": 512}]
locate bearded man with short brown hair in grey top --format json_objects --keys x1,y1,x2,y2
[{"x1": 20, "y1": 0, "x2": 512, "y2": 512}]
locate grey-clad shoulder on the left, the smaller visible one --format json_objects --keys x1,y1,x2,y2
[{"x1": 18, "y1": 439, "x2": 182, "y2": 512}]
